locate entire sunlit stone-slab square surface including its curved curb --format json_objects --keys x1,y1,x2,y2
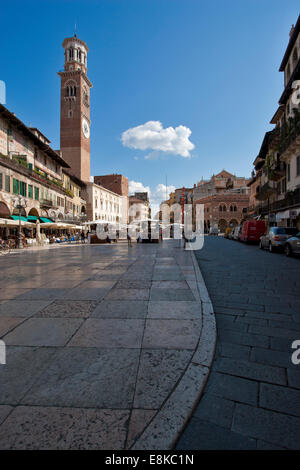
[{"x1": 0, "y1": 241, "x2": 216, "y2": 449}]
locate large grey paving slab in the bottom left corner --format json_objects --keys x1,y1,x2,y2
[{"x1": 0, "y1": 406, "x2": 129, "y2": 450}]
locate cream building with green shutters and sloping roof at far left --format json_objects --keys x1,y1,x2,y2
[{"x1": 0, "y1": 105, "x2": 85, "y2": 220}]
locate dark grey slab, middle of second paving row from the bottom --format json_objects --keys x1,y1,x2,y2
[{"x1": 21, "y1": 348, "x2": 139, "y2": 409}]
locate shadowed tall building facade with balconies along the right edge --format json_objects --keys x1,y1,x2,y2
[{"x1": 250, "y1": 16, "x2": 300, "y2": 229}]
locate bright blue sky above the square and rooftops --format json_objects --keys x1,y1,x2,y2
[{"x1": 0, "y1": 0, "x2": 299, "y2": 207}]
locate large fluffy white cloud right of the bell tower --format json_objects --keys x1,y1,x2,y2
[{"x1": 121, "y1": 121, "x2": 195, "y2": 158}]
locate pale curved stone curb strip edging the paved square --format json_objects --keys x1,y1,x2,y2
[{"x1": 131, "y1": 251, "x2": 217, "y2": 450}]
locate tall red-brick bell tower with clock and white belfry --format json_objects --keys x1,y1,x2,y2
[{"x1": 58, "y1": 34, "x2": 92, "y2": 181}]
